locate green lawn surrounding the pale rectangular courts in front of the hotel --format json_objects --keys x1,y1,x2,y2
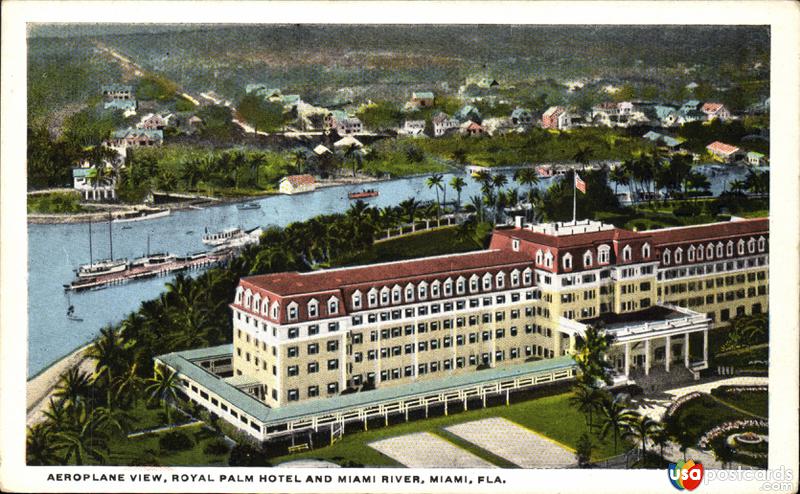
[{"x1": 272, "y1": 392, "x2": 623, "y2": 467}]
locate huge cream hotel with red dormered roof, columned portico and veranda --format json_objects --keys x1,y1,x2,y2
[{"x1": 157, "y1": 218, "x2": 769, "y2": 441}]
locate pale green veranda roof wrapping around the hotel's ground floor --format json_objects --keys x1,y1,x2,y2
[{"x1": 156, "y1": 344, "x2": 575, "y2": 423}]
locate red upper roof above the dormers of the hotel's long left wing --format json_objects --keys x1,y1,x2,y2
[{"x1": 242, "y1": 250, "x2": 531, "y2": 297}]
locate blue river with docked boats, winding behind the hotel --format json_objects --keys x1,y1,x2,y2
[{"x1": 28, "y1": 164, "x2": 764, "y2": 377}]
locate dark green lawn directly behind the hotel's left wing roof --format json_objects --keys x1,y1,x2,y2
[{"x1": 332, "y1": 227, "x2": 481, "y2": 266}]
